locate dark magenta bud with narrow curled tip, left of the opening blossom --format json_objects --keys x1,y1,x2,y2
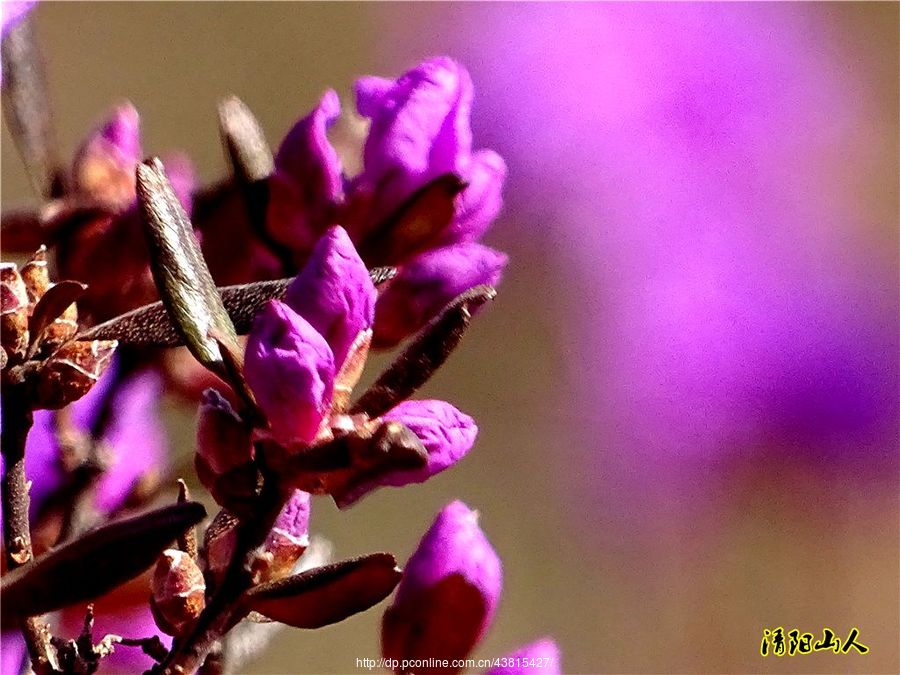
[{"x1": 267, "y1": 89, "x2": 343, "y2": 251}]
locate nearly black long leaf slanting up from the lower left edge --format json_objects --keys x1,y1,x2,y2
[{"x1": 0, "y1": 502, "x2": 206, "y2": 626}]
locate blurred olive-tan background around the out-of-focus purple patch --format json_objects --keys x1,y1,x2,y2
[{"x1": 2, "y1": 2, "x2": 900, "y2": 673}]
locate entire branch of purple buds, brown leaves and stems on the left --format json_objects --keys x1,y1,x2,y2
[{"x1": 0, "y1": 11, "x2": 559, "y2": 675}]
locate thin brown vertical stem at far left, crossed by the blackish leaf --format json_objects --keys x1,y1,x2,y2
[{"x1": 0, "y1": 387, "x2": 51, "y2": 675}]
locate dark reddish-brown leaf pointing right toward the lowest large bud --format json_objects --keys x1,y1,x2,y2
[{"x1": 244, "y1": 553, "x2": 402, "y2": 628}]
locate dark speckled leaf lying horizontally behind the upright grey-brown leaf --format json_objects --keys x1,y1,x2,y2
[{"x1": 76, "y1": 267, "x2": 396, "y2": 347}]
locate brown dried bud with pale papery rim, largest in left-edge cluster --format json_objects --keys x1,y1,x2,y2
[{"x1": 37, "y1": 340, "x2": 118, "y2": 410}]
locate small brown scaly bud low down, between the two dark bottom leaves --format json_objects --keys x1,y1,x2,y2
[{"x1": 150, "y1": 548, "x2": 206, "y2": 635}]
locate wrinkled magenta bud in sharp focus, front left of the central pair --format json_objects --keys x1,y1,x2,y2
[{"x1": 244, "y1": 300, "x2": 335, "y2": 443}]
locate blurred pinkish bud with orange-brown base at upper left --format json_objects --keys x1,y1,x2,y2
[{"x1": 73, "y1": 102, "x2": 142, "y2": 209}]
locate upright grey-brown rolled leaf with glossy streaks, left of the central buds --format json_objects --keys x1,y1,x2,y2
[{"x1": 137, "y1": 158, "x2": 237, "y2": 375}]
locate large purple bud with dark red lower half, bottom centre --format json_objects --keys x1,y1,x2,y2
[{"x1": 381, "y1": 501, "x2": 503, "y2": 673}]
